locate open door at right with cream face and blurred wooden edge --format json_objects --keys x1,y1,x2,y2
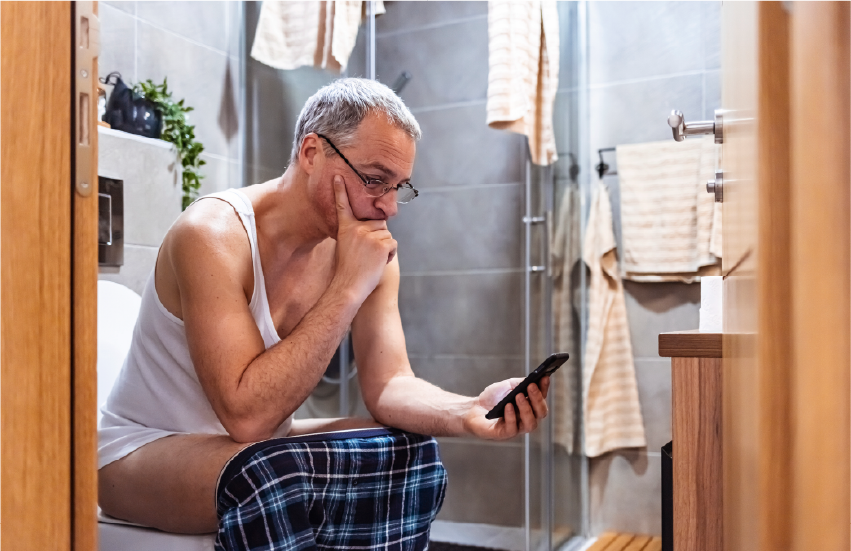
[{"x1": 721, "y1": 0, "x2": 792, "y2": 551}]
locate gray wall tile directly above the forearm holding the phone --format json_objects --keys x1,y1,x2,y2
[{"x1": 410, "y1": 355, "x2": 524, "y2": 396}]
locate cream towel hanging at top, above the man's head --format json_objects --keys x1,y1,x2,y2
[{"x1": 251, "y1": 0, "x2": 385, "y2": 72}]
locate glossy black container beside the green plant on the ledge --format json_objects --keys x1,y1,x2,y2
[{"x1": 101, "y1": 72, "x2": 163, "y2": 138}]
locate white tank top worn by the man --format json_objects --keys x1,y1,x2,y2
[{"x1": 98, "y1": 189, "x2": 292, "y2": 469}]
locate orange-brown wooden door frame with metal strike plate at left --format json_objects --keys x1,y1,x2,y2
[{"x1": 0, "y1": 0, "x2": 97, "y2": 551}]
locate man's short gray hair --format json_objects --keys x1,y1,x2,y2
[{"x1": 290, "y1": 78, "x2": 422, "y2": 163}]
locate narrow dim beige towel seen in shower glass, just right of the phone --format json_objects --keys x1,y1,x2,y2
[{"x1": 550, "y1": 185, "x2": 582, "y2": 453}]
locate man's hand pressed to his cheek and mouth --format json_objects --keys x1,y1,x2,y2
[{"x1": 334, "y1": 176, "x2": 397, "y2": 301}]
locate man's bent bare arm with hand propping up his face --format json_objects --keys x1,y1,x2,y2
[{"x1": 175, "y1": 181, "x2": 396, "y2": 442}]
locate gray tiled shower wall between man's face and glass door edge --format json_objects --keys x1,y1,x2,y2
[{"x1": 376, "y1": 0, "x2": 525, "y2": 527}]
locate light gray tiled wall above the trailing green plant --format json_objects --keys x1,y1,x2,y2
[{"x1": 99, "y1": 0, "x2": 244, "y2": 198}]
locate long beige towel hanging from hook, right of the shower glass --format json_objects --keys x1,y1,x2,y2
[{"x1": 582, "y1": 182, "x2": 647, "y2": 457}]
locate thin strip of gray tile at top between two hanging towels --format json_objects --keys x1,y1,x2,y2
[{"x1": 375, "y1": 0, "x2": 488, "y2": 34}]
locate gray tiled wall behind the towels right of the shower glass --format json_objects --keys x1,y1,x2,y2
[{"x1": 580, "y1": 0, "x2": 721, "y2": 534}]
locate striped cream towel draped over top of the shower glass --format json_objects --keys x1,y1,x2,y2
[{"x1": 487, "y1": 0, "x2": 559, "y2": 165}]
